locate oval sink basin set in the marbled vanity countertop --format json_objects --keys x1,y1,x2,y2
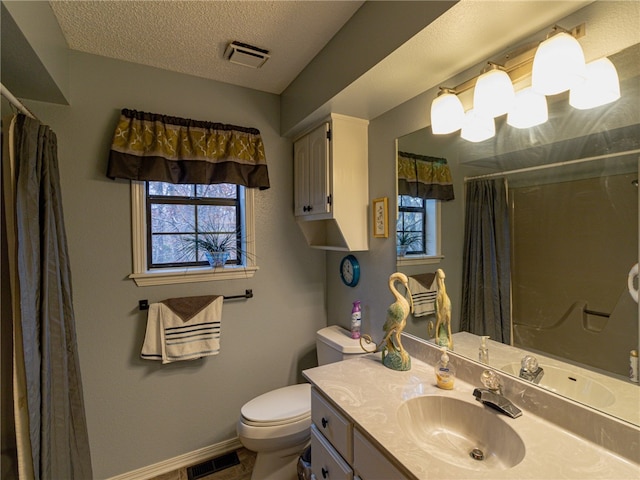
[{"x1": 398, "y1": 395, "x2": 525, "y2": 471}]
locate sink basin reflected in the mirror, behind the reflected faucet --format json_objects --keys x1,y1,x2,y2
[{"x1": 501, "y1": 362, "x2": 616, "y2": 408}]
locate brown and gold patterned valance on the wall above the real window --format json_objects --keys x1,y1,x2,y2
[{"x1": 107, "y1": 109, "x2": 269, "y2": 189}]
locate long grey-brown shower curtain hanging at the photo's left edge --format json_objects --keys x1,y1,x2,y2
[{"x1": 3, "y1": 114, "x2": 93, "y2": 480}]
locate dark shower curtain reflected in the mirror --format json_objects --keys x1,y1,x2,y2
[{"x1": 460, "y1": 179, "x2": 511, "y2": 344}]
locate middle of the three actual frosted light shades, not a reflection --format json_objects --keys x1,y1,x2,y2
[{"x1": 473, "y1": 68, "x2": 515, "y2": 118}]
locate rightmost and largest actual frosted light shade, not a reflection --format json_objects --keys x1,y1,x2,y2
[{"x1": 531, "y1": 32, "x2": 587, "y2": 95}]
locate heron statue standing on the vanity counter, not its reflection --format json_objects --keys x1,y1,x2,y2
[{"x1": 360, "y1": 272, "x2": 413, "y2": 371}]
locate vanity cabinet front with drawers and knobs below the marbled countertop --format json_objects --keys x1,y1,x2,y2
[{"x1": 311, "y1": 388, "x2": 406, "y2": 480}]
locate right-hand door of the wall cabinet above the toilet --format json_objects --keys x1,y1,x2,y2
[{"x1": 309, "y1": 123, "x2": 331, "y2": 215}]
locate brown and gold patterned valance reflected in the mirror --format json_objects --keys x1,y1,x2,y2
[{"x1": 398, "y1": 152, "x2": 454, "y2": 200}]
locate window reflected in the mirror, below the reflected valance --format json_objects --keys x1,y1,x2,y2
[{"x1": 396, "y1": 195, "x2": 441, "y2": 264}]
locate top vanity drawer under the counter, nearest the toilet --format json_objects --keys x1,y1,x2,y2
[{"x1": 311, "y1": 388, "x2": 353, "y2": 463}]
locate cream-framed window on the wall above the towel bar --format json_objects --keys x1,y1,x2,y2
[{"x1": 130, "y1": 181, "x2": 257, "y2": 285}]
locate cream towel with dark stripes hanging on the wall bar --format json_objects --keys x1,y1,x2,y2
[{"x1": 140, "y1": 296, "x2": 223, "y2": 363}]
